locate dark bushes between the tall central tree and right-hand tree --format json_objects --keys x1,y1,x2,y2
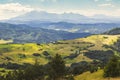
[{"x1": 69, "y1": 60, "x2": 101, "y2": 75}]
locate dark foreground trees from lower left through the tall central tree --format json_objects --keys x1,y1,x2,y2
[{"x1": 0, "y1": 54, "x2": 74, "y2": 80}]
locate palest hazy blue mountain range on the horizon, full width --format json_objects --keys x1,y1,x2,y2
[{"x1": 5, "y1": 11, "x2": 120, "y2": 23}]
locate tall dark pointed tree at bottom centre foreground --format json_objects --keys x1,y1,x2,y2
[{"x1": 48, "y1": 54, "x2": 66, "y2": 80}]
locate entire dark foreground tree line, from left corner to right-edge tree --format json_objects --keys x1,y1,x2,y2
[{"x1": 0, "y1": 54, "x2": 120, "y2": 80}]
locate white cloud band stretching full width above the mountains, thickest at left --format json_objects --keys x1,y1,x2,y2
[{"x1": 0, "y1": 3, "x2": 120, "y2": 20}]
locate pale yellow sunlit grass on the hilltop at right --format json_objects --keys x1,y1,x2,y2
[{"x1": 80, "y1": 35, "x2": 120, "y2": 50}]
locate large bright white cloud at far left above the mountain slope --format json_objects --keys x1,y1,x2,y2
[{"x1": 0, "y1": 3, "x2": 33, "y2": 20}]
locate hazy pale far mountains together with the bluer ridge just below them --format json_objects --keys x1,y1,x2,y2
[{"x1": 2, "y1": 11, "x2": 120, "y2": 34}]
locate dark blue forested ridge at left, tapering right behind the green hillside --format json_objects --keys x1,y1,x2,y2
[{"x1": 0, "y1": 23, "x2": 90, "y2": 43}]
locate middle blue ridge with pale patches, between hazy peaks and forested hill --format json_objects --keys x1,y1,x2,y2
[{"x1": 20, "y1": 21, "x2": 120, "y2": 34}]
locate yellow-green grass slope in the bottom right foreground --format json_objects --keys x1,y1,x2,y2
[{"x1": 75, "y1": 70, "x2": 120, "y2": 80}]
